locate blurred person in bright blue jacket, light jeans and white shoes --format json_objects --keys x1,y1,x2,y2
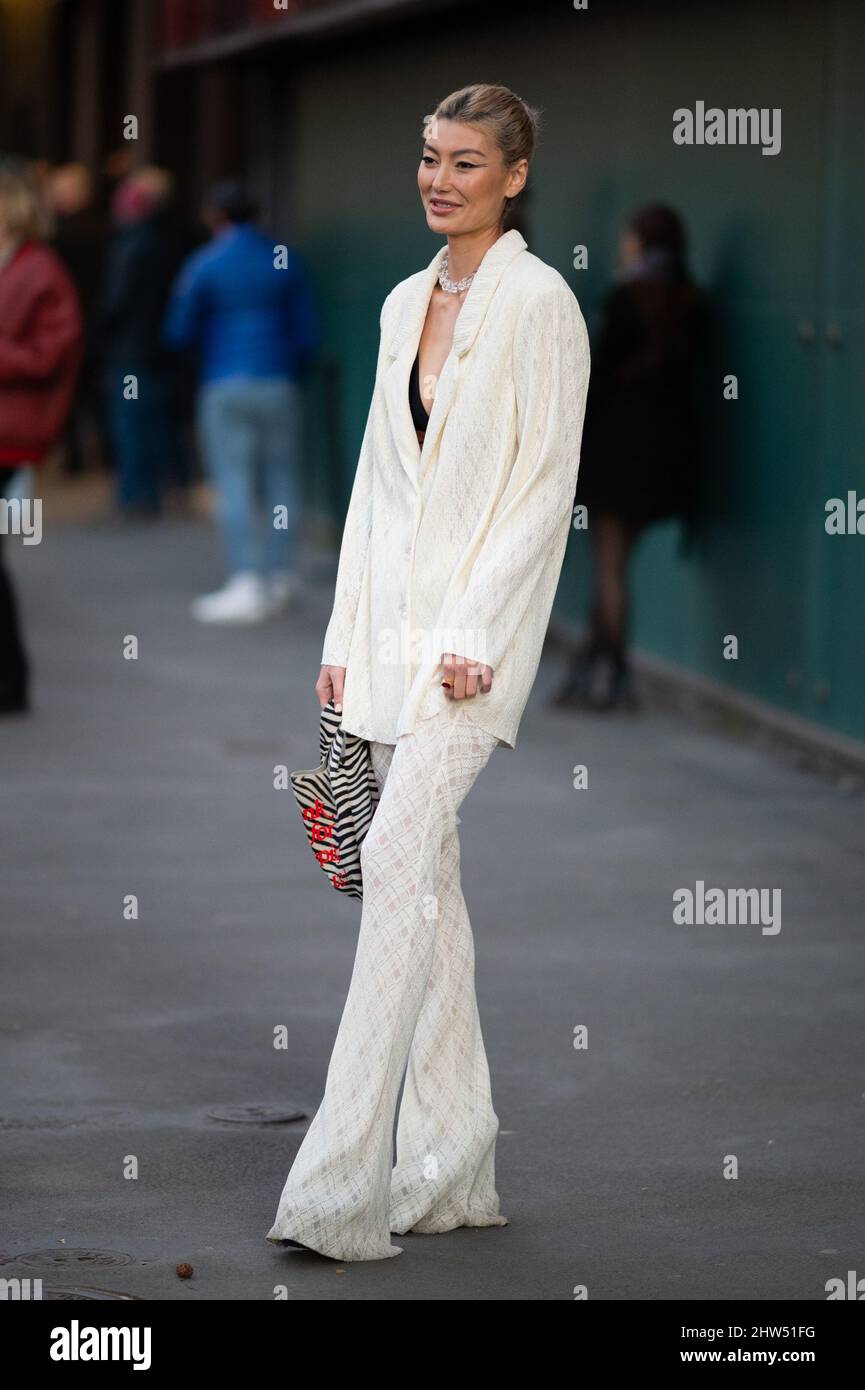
[{"x1": 163, "y1": 181, "x2": 318, "y2": 623}]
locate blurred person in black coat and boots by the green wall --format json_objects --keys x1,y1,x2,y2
[{"x1": 555, "y1": 204, "x2": 706, "y2": 709}]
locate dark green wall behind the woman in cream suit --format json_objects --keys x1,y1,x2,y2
[{"x1": 268, "y1": 0, "x2": 865, "y2": 738}]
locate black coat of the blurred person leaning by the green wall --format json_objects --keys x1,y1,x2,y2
[{"x1": 576, "y1": 279, "x2": 706, "y2": 521}]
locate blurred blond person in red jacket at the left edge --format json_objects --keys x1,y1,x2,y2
[{"x1": 0, "y1": 161, "x2": 83, "y2": 714}]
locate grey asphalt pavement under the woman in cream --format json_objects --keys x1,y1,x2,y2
[{"x1": 0, "y1": 521, "x2": 865, "y2": 1300}]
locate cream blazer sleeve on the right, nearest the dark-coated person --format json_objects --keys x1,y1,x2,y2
[{"x1": 442, "y1": 284, "x2": 590, "y2": 670}]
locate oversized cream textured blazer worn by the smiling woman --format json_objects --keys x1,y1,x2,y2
[{"x1": 321, "y1": 229, "x2": 590, "y2": 748}]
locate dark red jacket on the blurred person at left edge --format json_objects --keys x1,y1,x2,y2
[{"x1": 0, "y1": 242, "x2": 83, "y2": 466}]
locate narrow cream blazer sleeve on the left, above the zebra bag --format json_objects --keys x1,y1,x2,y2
[{"x1": 321, "y1": 292, "x2": 392, "y2": 666}]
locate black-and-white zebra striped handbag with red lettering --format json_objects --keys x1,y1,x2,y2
[{"x1": 289, "y1": 699, "x2": 378, "y2": 898}]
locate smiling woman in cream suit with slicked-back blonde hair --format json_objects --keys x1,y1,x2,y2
[{"x1": 266, "y1": 83, "x2": 590, "y2": 1261}]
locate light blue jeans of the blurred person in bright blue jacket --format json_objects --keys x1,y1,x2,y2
[{"x1": 197, "y1": 377, "x2": 302, "y2": 574}]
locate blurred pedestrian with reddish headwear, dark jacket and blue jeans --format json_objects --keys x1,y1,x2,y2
[{"x1": 99, "y1": 168, "x2": 184, "y2": 518}]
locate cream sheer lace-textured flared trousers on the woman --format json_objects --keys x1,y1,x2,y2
[{"x1": 266, "y1": 701, "x2": 508, "y2": 1261}]
